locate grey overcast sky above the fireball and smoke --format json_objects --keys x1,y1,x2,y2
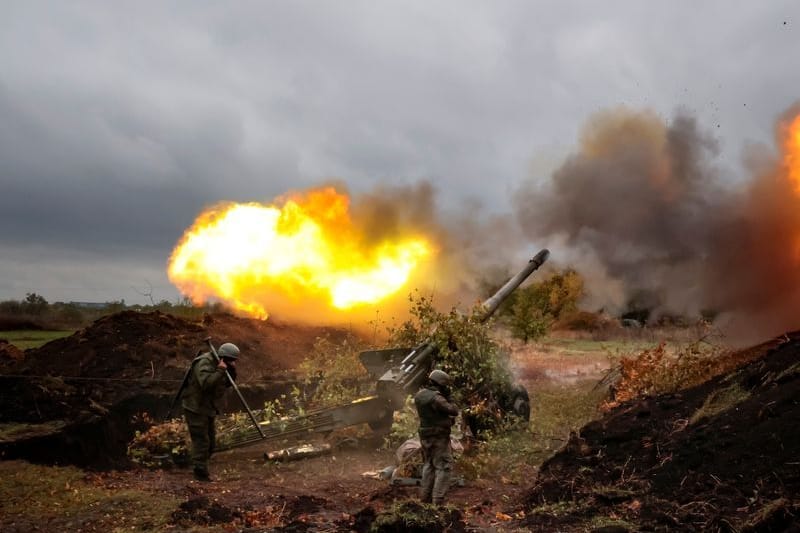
[{"x1": 0, "y1": 0, "x2": 800, "y2": 303}]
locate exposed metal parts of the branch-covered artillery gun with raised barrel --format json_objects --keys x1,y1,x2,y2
[{"x1": 212, "y1": 249, "x2": 550, "y2": 451}]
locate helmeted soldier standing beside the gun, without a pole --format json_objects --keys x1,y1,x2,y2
[{"x1": 414, "y1": 370, "x2": 458, "y2": 505}]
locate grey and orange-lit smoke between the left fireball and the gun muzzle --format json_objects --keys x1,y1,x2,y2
[{"x1": 340, "y1": 181, "x2": 528, "y2": 314}]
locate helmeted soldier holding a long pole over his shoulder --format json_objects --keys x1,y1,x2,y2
[{"x1": 182, "y1": 342, "x2": 239, "y2": 481}]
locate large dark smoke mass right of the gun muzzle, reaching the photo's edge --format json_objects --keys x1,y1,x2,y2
[{"x1": 515, "y1": 103, "x2": 800, "y2": 334}]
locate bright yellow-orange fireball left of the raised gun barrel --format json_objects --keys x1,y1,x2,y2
[{"x1": 168, "y1": 187, "x2": 433, "y2": 318}]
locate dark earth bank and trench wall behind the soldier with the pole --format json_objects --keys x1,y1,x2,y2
[{"x1": 0, "y1": 311, "x2": 347, "y2": 467}]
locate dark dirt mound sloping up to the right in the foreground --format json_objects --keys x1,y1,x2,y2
[{"x1": 524, "y1": 332, "x2": 800, "y2": 531}]
